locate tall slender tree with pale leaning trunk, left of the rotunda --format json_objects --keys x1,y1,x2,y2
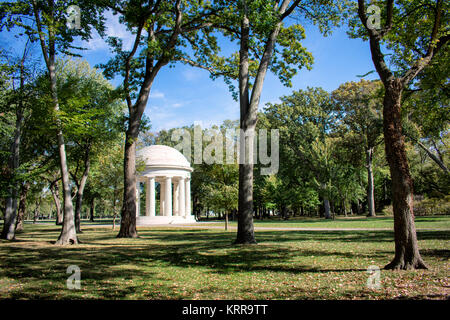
[{"x1": 0, "y1": 0, "x2": 102, "y2": 244}]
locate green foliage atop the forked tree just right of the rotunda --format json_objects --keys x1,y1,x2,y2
[{"x1": 210, "y1": 0, "x2": 347, "y2": 100}]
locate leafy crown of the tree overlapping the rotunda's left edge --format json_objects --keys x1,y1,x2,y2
[{"x1": 100, "y1": 0, "x2": 225, "y2": 100}]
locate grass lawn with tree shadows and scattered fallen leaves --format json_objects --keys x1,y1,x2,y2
[{"x1": 0, "y1": 216, "x2": 450, "y2": 299}]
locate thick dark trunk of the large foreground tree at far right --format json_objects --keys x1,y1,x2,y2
[{"x1": 383, "y1": 80, "x2": 427, "y2": 270}]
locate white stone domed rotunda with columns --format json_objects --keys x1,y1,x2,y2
[{"x1": 136, "y1": 145, "x2": 196, "y2": 226}]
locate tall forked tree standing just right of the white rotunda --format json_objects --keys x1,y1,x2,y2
[{"x1": 212, "y1": 0, "x2": 341, "y2": 244}]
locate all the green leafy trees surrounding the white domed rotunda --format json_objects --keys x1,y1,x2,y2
[{"x1": 0, "y1": 0, "x2": 450, "y2": 269}]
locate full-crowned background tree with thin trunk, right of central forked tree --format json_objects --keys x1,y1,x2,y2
[{"x1": 265, "y1": 88, "x2": 339, "y2": 219}]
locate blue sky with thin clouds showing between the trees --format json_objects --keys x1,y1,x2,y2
[{"x1": 1, "y1": 9, "x2": 376, "y2": 131}]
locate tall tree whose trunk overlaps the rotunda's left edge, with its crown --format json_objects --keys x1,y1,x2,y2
[{"x1": 102, "y1": 0, "x2": 224, "y2": 238}]
